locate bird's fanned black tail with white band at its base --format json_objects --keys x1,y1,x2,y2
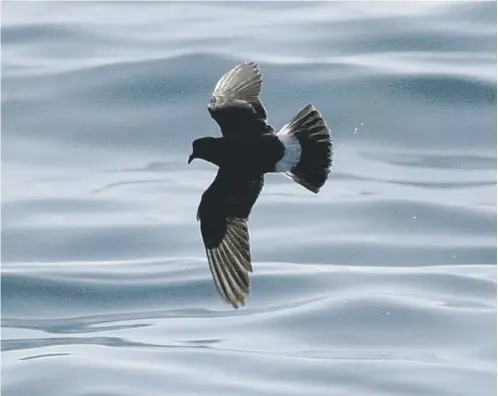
[{"x1": 275, "y1": 104, "x2": 332, "y2": 194}]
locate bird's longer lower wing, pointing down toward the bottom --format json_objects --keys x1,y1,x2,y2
[{"x1": 197, "y1": 169, "x2": 264, "y2": 308}]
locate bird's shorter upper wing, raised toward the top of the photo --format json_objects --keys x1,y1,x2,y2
[{"x1": 208, "y1": 62, "x2": 273, "y2": 137}]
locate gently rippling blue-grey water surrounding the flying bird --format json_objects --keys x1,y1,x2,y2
[{"x1": 2, "y1": 1, "x2": 497, "y2": 396}]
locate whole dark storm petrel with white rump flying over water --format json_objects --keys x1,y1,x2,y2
[{"x1": 188, "y1": 62, "x2": 332, "y2": 308}]
